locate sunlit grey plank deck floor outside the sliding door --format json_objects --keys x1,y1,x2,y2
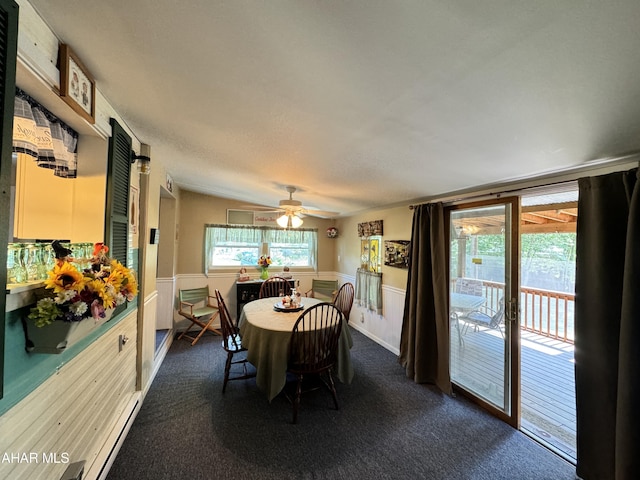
[{"x1": 451, "y1": 323, "x2": 576, "y2": 462}]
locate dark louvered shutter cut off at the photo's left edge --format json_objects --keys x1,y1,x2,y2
[{"x1": 0, "y1": 0, "x2": 18, "y2": 398}]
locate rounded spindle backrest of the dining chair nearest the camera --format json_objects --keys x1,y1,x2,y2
[{"x1": 289, "y1": 302, "x2": 342, "y2": 373}]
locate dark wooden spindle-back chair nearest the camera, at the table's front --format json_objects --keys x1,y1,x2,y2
[{"x1": 287, "y1": 302, "x2": 342, "y2": 423}]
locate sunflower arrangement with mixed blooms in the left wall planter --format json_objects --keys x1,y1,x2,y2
[{"x1": 29, "y1": 242, "x2": 138, "y2": 327}]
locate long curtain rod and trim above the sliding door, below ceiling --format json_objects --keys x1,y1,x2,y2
[{"x1": 409, "y1": 151, "x2": 640, "y2": 210}]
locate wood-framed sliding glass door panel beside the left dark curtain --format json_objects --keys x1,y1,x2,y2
[{"x1": 446, "y1": 198, "x2": 519, "y2": 427}]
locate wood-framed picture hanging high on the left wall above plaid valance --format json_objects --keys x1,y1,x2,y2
[{"x1": 60, "y1": 44, "x2": 96, "y2": 124}]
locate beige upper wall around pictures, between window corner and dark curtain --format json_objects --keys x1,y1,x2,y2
[{"x1": 335, "y1": 206, "x2": 413, "y2": 289}]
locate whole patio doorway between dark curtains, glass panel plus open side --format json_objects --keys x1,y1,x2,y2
[{"x1": 447, "y1": 184, "x2": 578, "y2": 463}]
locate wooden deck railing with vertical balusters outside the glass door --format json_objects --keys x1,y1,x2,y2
[{"x1": 456, "y1": 280, "x2": 575, "y2": 343}]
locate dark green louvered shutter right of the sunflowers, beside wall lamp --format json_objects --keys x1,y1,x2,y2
[{"x1": 105, "y1": 118, "x2": 131, "y2": 267}]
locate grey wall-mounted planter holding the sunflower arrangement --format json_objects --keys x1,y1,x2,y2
[{"x1": 23, "y1": 308, "x2": 114, "y2": 353}]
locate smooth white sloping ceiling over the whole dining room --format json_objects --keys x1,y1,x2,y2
[{"x1": 22, "y1": 0, "x2": 640, "y2": 215}]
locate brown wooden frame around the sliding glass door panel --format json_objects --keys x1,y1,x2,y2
[{"x1": 444, "y1": 196, "x2": 520, "y2": 429}]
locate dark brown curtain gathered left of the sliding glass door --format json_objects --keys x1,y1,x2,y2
[{"x1": 398, "y1": 203, "x2": 451, "y2": 394}]
